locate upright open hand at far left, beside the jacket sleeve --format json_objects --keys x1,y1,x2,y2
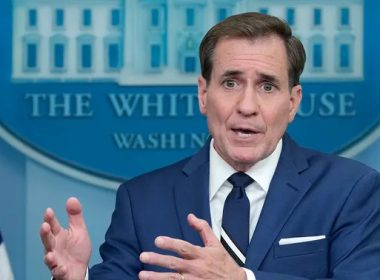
[{"x1": 40, "y1": 198, "x2": 91, "y2": 280}]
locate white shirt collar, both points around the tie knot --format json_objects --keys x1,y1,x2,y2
[{"x1": 209, "y1": 139, "x2": 282, "y2": 200}]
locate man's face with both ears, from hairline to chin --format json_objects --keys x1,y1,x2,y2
[{"x1": 198, "y1": 35, "x2": 302, "y2": 171}]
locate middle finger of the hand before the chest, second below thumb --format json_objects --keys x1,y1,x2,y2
[{"x1": 140, "y1": 252, "x2": 185, "y2": 271}]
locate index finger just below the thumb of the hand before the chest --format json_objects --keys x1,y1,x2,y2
[{"x1": 154, "y1": 236, "x2": 200, "y2": 259}]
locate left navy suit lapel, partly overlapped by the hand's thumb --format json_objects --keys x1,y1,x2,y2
[{"x1": 174, "y1": 139, "x2": 211, "y2": 246}]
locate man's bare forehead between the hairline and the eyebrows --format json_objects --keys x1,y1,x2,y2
[{"x1": 213, "y1": 35, "x2": 288, "y2": 78}]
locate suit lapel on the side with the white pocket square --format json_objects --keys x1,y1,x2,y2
[{"x1": 246, "y1": 135, "x2": 310, "y2": 269}]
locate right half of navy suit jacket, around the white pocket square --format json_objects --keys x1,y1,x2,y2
[{"x1": 246, "y1": 135, "x2": 380, "y2": 280}]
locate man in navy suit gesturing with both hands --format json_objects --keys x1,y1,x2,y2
[{"x1": 40, "y1": 13, "x2": 380, "y2": 280}]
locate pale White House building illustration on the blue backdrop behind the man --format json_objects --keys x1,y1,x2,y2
[{"x1": 12, "y1": 0, "x2": 364, "y2": 85}]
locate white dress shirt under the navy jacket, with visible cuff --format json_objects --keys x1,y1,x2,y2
[{"x1": 209, "y1": 139, "x2": 282, "y2": 280}]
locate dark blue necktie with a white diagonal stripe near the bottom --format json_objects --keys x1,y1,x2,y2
[{"x1": 221, "y1": 172, "x2": 253, "y2": 266}]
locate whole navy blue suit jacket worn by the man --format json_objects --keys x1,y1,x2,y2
[{"x1": 90, "y1": 135, "x2": 380, "y2": 280}]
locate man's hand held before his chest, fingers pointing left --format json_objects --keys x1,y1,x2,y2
[{"x1": 139, "y1": 214, "x2": 246, "y2": 280}]
